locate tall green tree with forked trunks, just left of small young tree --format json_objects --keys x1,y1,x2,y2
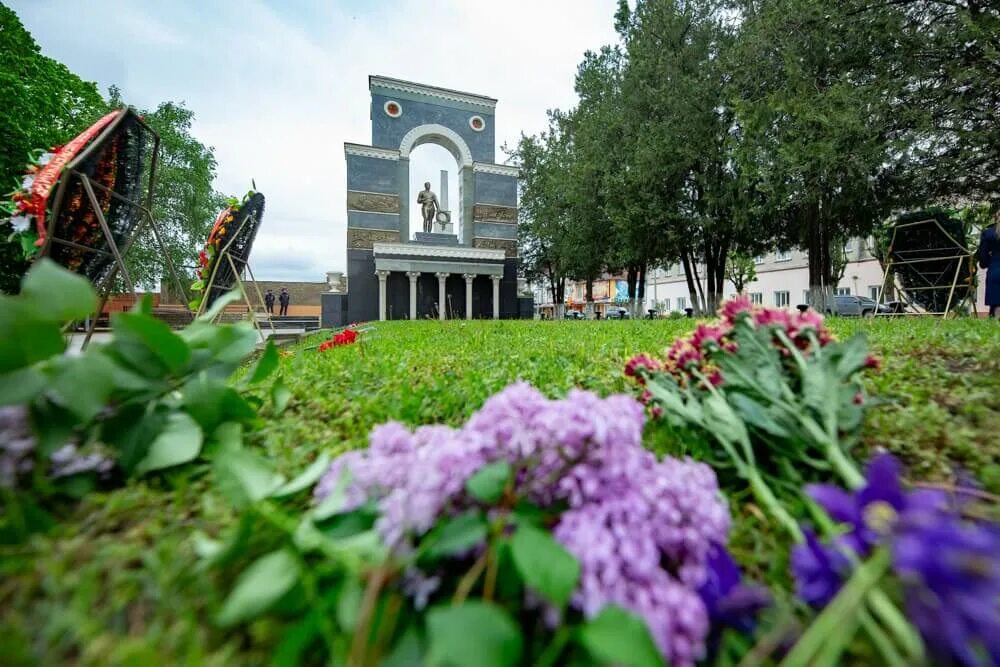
[{"x1": 616, "y1": 0, "x2": 767, "y2": 312}]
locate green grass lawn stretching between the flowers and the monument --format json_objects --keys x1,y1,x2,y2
[{"x1": 0, "y1": 319, "x2": 1000, "y2": 665}]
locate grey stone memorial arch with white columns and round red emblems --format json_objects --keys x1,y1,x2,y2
[{"x1": 336, "y1": 76, "x2": 519, "y2": 325}]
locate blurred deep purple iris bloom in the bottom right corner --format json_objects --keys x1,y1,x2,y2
[{"x1": 893, "y1": 513, "x2": 1000, "y2": 665}]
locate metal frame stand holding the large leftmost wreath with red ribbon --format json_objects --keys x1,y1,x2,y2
[{"x1": 34, "y1": 109, "x2": 186, "y2": 349}]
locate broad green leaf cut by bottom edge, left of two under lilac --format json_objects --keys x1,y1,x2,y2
[{"x1": 427, "y1": 600, "x2": 523, "y2": 667}]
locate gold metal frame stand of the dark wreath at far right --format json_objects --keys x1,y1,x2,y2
[{"x1": 875, "y1": 218, "x2": 979, "y2": 318}]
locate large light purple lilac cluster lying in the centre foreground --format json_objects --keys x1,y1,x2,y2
[{"x1": 315, "y1": 383, "x2": 729, "y2": 665}]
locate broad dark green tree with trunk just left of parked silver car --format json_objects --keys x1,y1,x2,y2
[{"x1": 733, "y1": 0, "x2": 908, "y2": 309}]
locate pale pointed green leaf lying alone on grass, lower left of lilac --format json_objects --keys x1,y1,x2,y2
[{"x1": 218, "y1": 549, "x2": 300, "y2": 627}]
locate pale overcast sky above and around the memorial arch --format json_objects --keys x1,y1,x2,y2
[{"x1": 11, "y1": 0, "x2": 616, "y2": 281}]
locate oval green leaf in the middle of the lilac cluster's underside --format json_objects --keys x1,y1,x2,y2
[{"x1": 510, "y1": 523, "x2": 580, "y2": 607}]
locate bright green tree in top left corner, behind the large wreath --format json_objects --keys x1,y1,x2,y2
[{"x1": 0, "y1": 4, "x2": 107, "y2": 294}]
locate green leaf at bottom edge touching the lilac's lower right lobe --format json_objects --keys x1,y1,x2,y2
[{"x1": 579, "y1": 606, "x2": 665, "y2": 667}]
